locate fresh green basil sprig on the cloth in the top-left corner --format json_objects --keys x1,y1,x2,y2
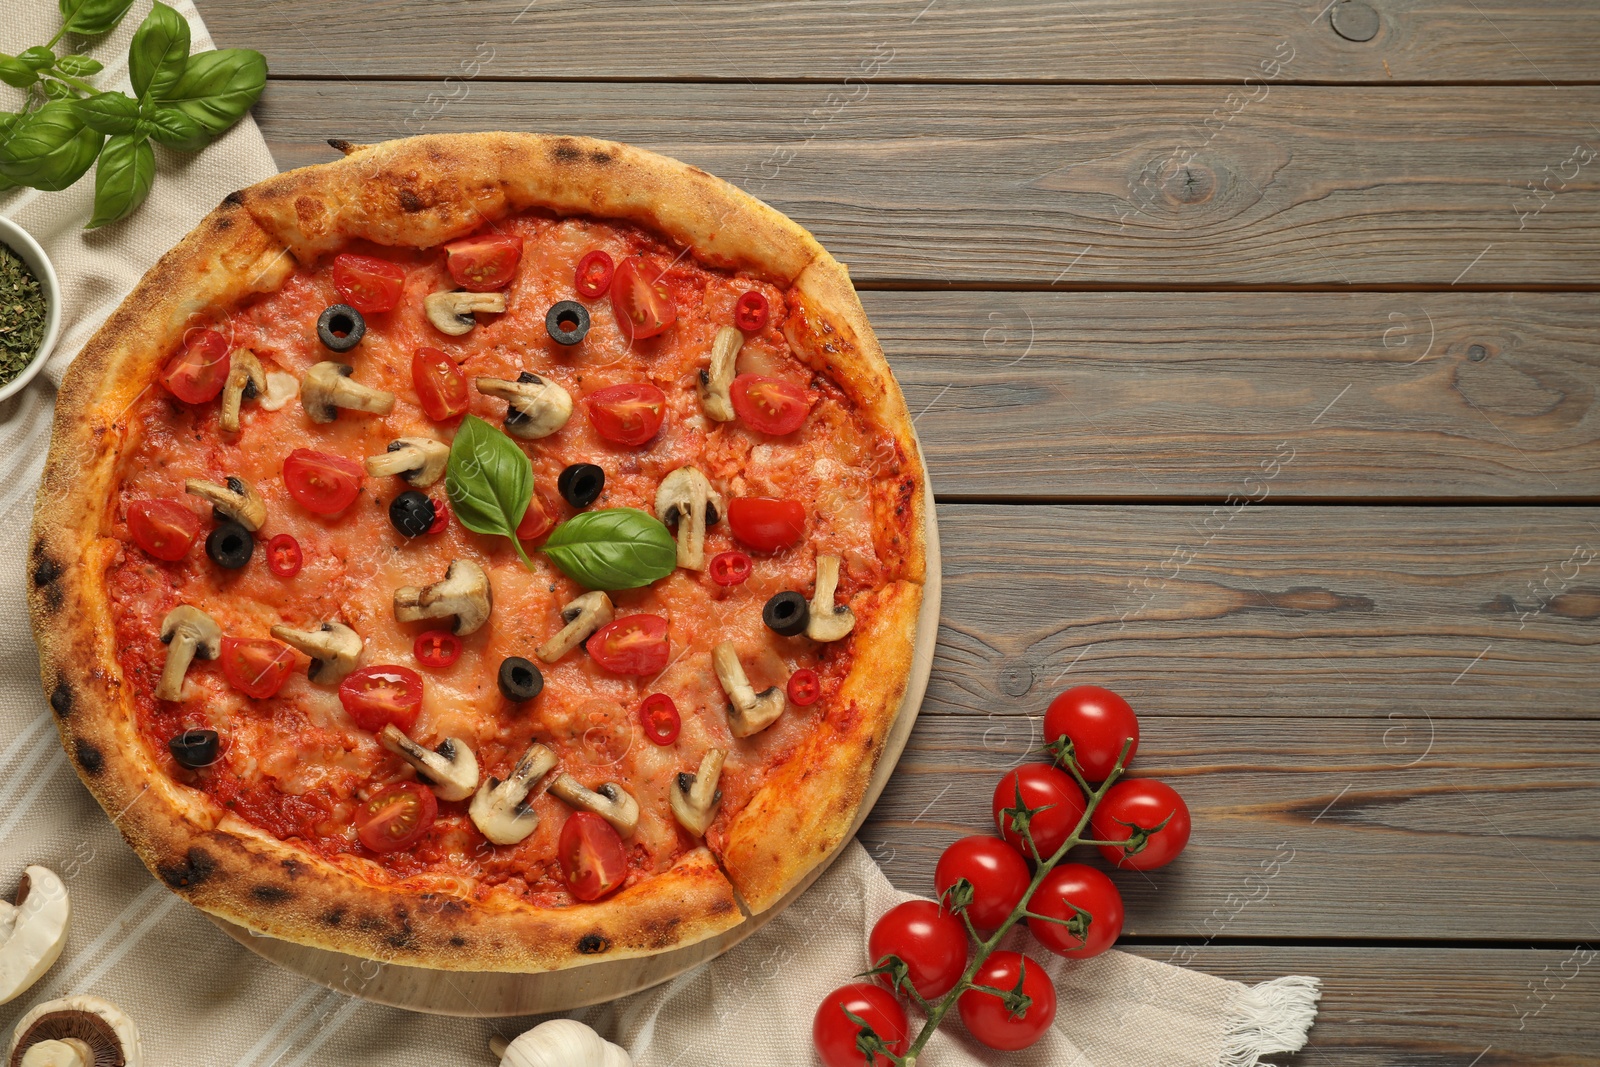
[{"x1": 0, "y1": 0, "x2": 267, "y2": 229}]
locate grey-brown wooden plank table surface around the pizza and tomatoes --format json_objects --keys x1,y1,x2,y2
[{"x1": 205, "y1": 0, "x2": 1600, "y2": 1067}]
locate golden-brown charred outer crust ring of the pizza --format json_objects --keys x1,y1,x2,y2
[{"x1": 29, "y1": 133, "x2": 926, "y2": 971}]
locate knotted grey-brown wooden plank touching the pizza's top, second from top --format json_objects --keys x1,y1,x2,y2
[{"x1": 258, "y1": 81, "x2": 1600, "y2": 288}]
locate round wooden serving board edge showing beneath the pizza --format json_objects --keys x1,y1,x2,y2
[{"x1": 208, "y1": 469, "x2": 941, "y2": 1019}]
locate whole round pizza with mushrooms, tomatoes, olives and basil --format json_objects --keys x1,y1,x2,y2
[{"x1": 30, "y1": 133, "x2": 928, "y2": 971}]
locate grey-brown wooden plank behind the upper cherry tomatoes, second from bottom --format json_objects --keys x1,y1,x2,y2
[{"x1": 861, "y1": 713, "x2": 1600, "y2": 941}]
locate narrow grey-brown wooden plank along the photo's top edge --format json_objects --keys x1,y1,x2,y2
[{"x1": 205, "y1": 0, "x2": 1600, "y2": 83}]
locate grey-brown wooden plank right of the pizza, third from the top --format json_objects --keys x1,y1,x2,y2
[{"x1": 862, "y1": 291, "x2": 1600, "y2": 501}]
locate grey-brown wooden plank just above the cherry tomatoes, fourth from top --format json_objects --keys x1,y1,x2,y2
[{"x1": 928, "y1": 508, "x2": 1600, "y2": 716}]
